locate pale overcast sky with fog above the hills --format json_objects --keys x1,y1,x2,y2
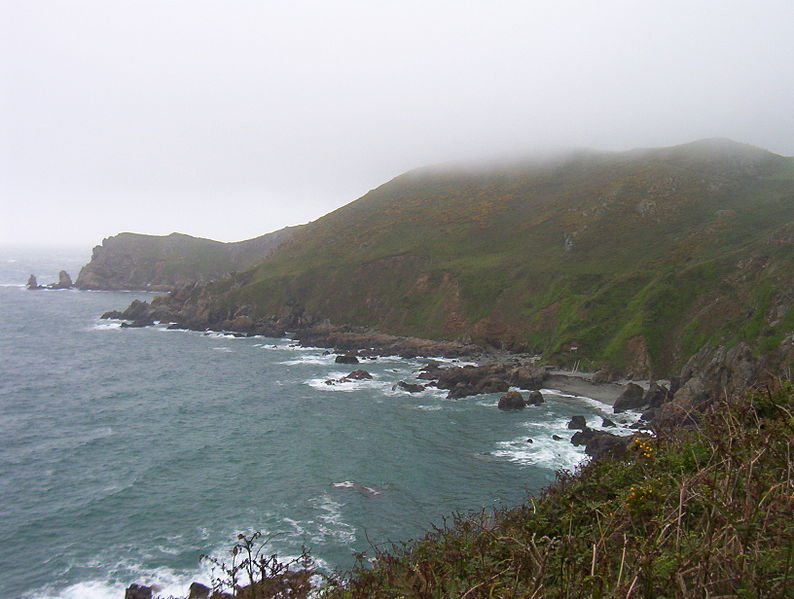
[{"x1": 0, "y1": 0, "x2": 794, "y2": 247}]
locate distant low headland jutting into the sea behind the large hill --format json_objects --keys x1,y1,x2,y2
[{"x1": 76, "y1": 227, "x2": 300, "y2": 291}]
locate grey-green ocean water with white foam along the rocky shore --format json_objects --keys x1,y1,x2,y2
[{"x1": 0, "y1": 249, "x2": 632, "y2": 599}]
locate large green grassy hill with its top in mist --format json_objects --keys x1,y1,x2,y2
[{"x1": 175, "y1": 140, "x2": 794, "y2": 375}]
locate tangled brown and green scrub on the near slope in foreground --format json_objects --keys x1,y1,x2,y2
[{"x1": 201, "y1": 383, "x2": 794, "y2": 599}]
